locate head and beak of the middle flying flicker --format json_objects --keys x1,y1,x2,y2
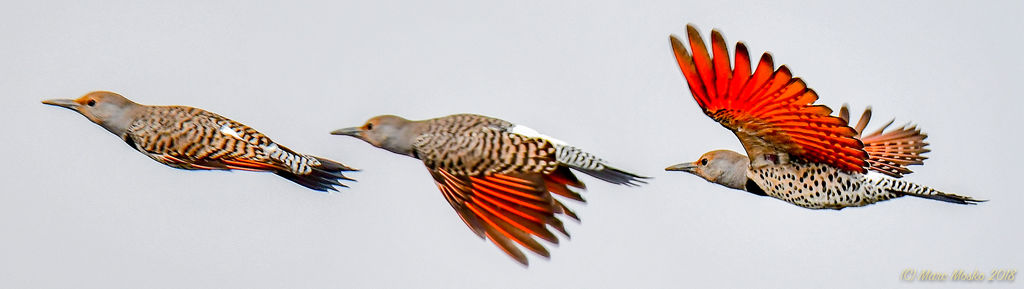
[{"x1": 331, "y1": 115, "x2": 419, "y2": 157}]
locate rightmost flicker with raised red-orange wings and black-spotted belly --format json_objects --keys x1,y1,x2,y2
[{"x1": 666, "y1": 26, "x2": 982, "y2": 209}]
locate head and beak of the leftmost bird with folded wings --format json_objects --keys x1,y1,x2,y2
[{"x1": 43, "y1": 91, "x2": 141, "y2": 135}]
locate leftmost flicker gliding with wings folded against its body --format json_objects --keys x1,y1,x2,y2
[{"x1": 43, "y1": 91, "x2": 355, "y2": 192}]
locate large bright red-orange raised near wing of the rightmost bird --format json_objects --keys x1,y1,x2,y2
[{"x1": 671, "y1": 26, "x2": 867, "y2": 172}]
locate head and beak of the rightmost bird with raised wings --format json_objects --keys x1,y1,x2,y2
[{"x1": 665, "y1": 150, "x2": 751, "y2": 190}]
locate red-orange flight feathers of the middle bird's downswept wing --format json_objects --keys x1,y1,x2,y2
[{"x1": 430, "y1": 169, "x2": 582, "y2": 264}]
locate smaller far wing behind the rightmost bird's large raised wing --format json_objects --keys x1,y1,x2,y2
[{"x1": 839, "y1": 105, "x2": 931, "y2": 177}]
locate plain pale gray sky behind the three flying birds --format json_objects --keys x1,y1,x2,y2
[{"x1": 0, "y1": 1, "x2": 1024, "y2": 288}]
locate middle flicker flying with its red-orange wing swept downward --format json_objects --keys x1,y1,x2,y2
[{"x1": 331, "y1": 115, "x2": 646, "y2": 265}]
